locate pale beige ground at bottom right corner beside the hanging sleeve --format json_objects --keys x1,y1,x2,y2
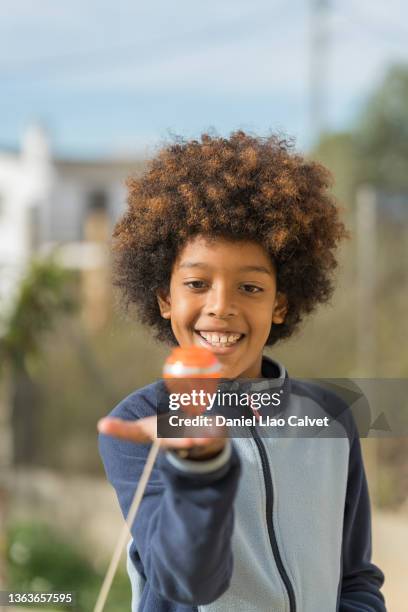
[{"x1": 372, "y1": 510, "x2": 408, "y2": 612}]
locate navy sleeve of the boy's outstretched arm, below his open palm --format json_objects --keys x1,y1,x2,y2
[{"x1": 99, "y1": 394, "x2": 241, "y2": 605}]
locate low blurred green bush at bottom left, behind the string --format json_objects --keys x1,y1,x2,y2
[{"x1": 7, "y1": 523, "x2": 131, "y2": 612}]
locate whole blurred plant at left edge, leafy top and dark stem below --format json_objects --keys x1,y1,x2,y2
[{"x1": 0, "y1": 257, "x2": 77, "y2": 464}]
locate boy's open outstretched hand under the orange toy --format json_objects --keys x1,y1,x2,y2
[{"x1": 98, "y1": 416, "x2": 227, "y2": 458}]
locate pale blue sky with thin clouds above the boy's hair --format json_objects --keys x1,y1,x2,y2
[{"x1": 0, "y1": 0, "x2": 408, "y2": 157}]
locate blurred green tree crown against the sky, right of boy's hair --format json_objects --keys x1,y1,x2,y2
[{"x1": 312, "y1": 64, "x2": 408, "y2": 194}]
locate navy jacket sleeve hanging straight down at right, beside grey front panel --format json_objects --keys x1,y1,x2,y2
[{"x1": 339, "y1": 431, "x2": 386, "y2": 612}]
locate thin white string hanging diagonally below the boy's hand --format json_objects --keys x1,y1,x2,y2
[{"x1": 94, "y1": 438, "x2": 161, "y2": 612}]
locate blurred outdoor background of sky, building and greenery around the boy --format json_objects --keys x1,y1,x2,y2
[{"x1": 0, "y1": 0, "x2": 408, "y2": 612}]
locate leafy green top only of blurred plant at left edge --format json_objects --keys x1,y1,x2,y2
[{"x1": 0, "y1": 258, "x2": 77, "y2": 371}]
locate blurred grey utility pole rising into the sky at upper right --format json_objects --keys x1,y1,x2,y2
[{"x1": 309, "y1": 0, "x2": 330, "y2": 143}]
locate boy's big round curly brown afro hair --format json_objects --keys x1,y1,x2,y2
[{"x1": 113, "y1": 131, "x2": 348, "y2": 345}]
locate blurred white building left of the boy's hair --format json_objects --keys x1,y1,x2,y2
[{"x1": 0, "y1": 126, "x2": 143, "y2": 310}]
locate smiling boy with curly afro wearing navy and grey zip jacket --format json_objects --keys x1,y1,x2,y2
[{"x1": 99, "y1": 132, "x2": 385, "y2": 612}]
